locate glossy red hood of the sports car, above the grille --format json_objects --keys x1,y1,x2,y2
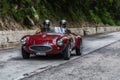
[{"x1": 29, "y1": 33, "x2": 64, "y2": 45}]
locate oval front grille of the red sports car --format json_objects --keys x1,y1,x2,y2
[{"x1": 30, "y1": 46, "x2": 51, "y2": 52}]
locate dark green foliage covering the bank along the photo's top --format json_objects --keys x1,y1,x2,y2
[{"x1": 0, "y1": 0, "x2": 120, "y2": 25}]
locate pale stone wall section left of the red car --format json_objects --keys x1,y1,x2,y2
[{"x1": 0, "y1": 30, "x2": 35, "y2": 49}]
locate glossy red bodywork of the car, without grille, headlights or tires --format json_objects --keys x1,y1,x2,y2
[{"x1": 22, "y1": 33, "x2": 82, "y2": 55}]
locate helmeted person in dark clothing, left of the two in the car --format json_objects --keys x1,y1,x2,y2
[{"x1": 36, "y1": 19, "x2": 51, "y2": 33}]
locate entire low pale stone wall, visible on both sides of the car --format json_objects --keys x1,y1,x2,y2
[{"x1": 0, "y1": 27, "x2": 120, "y2": 49}]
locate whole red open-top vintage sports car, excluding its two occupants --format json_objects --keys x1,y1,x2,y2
[{"x1": 21, "y1": 33, "x2": 82, "y2": 60}]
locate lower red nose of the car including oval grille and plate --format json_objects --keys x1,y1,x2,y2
[{"x1": 23, "y1": 45, "x2": 65, "y2": 55}]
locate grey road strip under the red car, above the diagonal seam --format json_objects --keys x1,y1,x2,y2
[{"x1": 0, "y1": 32, "x2": 120, "y2": 80}]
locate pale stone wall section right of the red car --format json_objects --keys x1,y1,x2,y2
[{"x1": 70, "y1": 26, "x2": 120, "y2": 36}]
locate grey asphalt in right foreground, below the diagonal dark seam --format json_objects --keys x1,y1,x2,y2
[{"x1": 23, "y1": 41, "x2": 120, "y2": 80}]
